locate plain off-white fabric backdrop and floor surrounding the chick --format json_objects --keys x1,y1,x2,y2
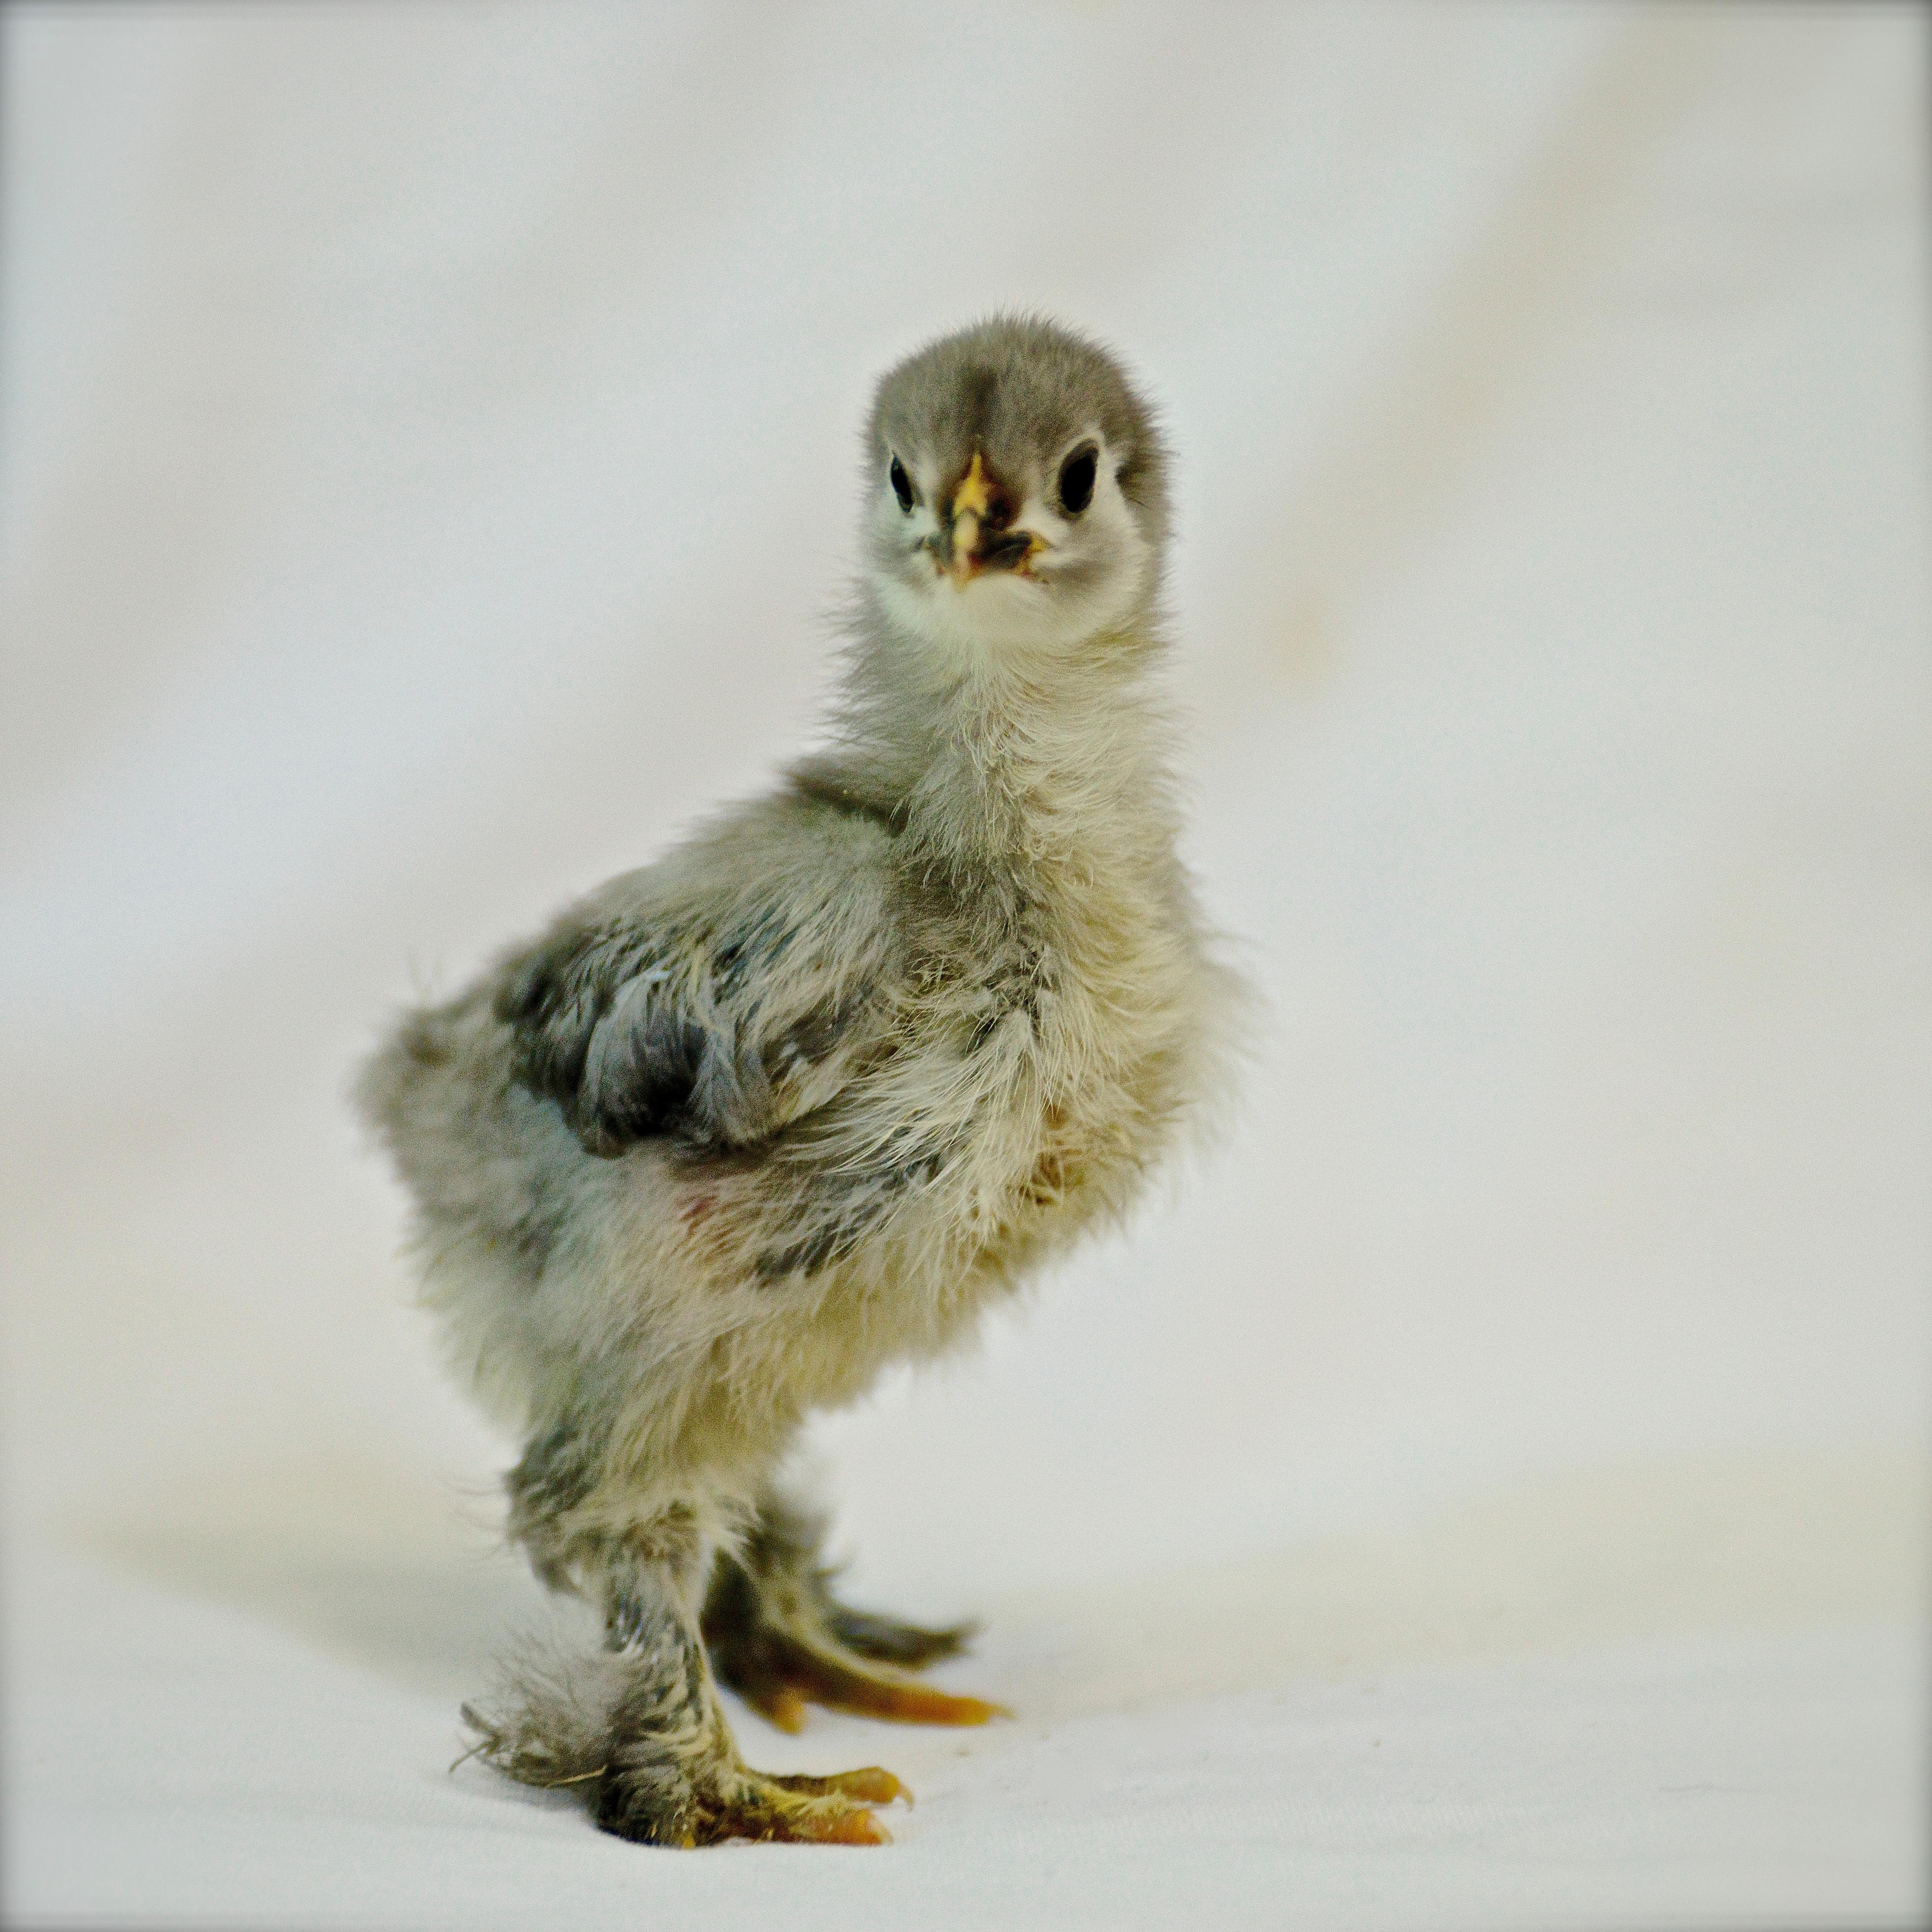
[{"x1": 0, "y1": 6, "x2": 1932, "y2": 1928}]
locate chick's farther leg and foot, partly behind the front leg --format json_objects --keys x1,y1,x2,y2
[{"x1": 701, "y1": 1491, "x2": 1005, "y2": 1731}]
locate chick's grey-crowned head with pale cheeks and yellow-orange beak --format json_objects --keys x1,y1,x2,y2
[{"x1": 864, "y1": 317, "x2": 1167, "y2": 661}]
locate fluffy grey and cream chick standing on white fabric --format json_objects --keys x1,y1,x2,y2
[{"x1": 359, "y1": 317, "x2": 1239, "y2": 1845}]
